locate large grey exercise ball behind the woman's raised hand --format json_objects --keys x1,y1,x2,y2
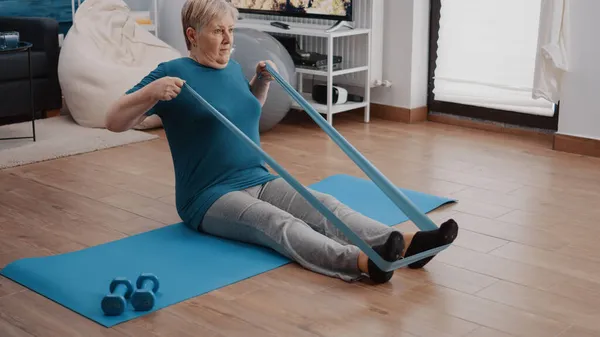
[{"x1": 232, "y1": 28, "x2": 296, "y2": 132}]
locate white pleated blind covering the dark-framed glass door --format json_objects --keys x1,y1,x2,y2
[{"x1": 433, "y1": 0, "x2": 554, "y2": 116}]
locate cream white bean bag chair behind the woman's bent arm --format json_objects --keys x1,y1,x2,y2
[{"x1": 58, "y1": 0, "x2": 181, "y2": 129}]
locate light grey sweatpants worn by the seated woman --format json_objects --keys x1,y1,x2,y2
[{"x1": 200, "y1": 178, "x2": 395, "y2": 281}]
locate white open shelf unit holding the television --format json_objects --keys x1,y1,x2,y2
[{"x1": 237, "y1": 18, "x2": 371, "y2": 125}]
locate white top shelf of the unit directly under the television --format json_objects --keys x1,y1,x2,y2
[{"x1": 236, "y1": 19, "x2": 370, "y2": 37}]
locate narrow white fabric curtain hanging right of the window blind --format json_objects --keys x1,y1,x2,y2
[{"x1": 527, "y1": 0, "x2": 569, "y2": 103}]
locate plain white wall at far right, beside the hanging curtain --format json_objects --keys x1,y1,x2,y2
[{"x1": 558, "y1": 0, "x2": 600, "y2": 139}]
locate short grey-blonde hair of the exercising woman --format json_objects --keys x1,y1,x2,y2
[{"x1": 181, "y1": 0, "x2": 239, "y2": 50}]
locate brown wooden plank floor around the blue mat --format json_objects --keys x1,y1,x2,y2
[{"x1": 0, "y1": 114, "x2": 600, "y2": 337}]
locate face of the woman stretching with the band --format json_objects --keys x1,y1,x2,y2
[{"x1": 186, "y1": 15, "x2": 235, "y2": 68}]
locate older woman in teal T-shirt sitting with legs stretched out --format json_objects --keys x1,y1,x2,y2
[{"x1": 106, "y1": 0, "x2": 458, "y2": 283}]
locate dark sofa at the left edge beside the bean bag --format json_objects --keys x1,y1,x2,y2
[{"x1": 0, "y1": 16, "x2": 62, "y2": 123}]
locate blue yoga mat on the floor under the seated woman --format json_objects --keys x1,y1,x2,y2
[{"x1": 0, "y1": 175, "x2": 454, "y2": 327}]
